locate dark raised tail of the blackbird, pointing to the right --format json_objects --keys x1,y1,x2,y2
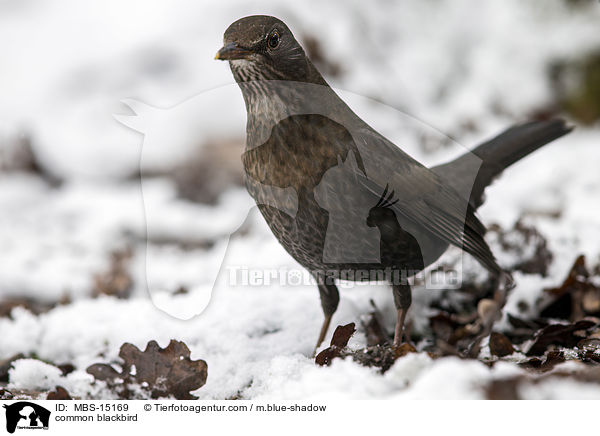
[{"x1": 432, "y1": 119, "x2": 573, "y2": 208}]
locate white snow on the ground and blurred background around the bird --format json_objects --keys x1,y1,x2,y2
[{"x1": 0, "y1": 0, "x2": 600, "y2": 399}]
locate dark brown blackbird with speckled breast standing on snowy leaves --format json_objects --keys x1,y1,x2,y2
[{"x1": 216, "y1": 15, "x2": 571, "y2": 352}]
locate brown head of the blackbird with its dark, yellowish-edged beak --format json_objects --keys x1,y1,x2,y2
[{"x1": 215, "y1": 15, "x2": 311, "y2": 82}]
